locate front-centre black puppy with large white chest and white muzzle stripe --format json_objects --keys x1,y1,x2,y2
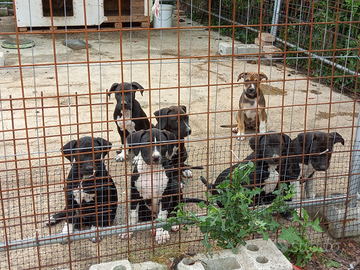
[{"x1": 120, "y1": 128, "x2": 181, "y2": 244}]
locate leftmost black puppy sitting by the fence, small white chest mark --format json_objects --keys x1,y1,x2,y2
[{"x1": 47, "y1": 137, "x2": 118, "y2": 242}]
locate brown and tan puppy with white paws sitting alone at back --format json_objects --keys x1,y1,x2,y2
[{"x1": 221, "y1": 71, "x2": 268, "y2": 141}]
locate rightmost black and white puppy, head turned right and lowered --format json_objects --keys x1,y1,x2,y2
[{"x1": 282, "y1": 131, "x2": 345, "y2": 200}]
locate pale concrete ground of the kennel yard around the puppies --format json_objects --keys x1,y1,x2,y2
[{"x1": 0, "y1": 11, "x2": 358, "y2": 269}]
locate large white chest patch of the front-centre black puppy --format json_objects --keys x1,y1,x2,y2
[{"x1": 135, "y1": 155, "x2": 169, "y2": 212}]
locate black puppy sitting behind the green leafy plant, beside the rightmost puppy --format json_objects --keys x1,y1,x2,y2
[{"x1": 201, "y1": 133, "x2": 291, "y2": 207}]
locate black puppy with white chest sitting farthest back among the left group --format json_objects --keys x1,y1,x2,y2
[{"x1": 109, "y1": 82, "x2": 150, "y2": 161}]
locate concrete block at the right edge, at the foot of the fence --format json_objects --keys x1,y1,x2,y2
[{"x1": 325, "y1": 202, "x2": 360, "y2": 238}]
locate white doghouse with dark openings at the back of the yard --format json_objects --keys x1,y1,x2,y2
[{"x1": 16, "y1": 0, "x2": 148, "y2": 31}]
